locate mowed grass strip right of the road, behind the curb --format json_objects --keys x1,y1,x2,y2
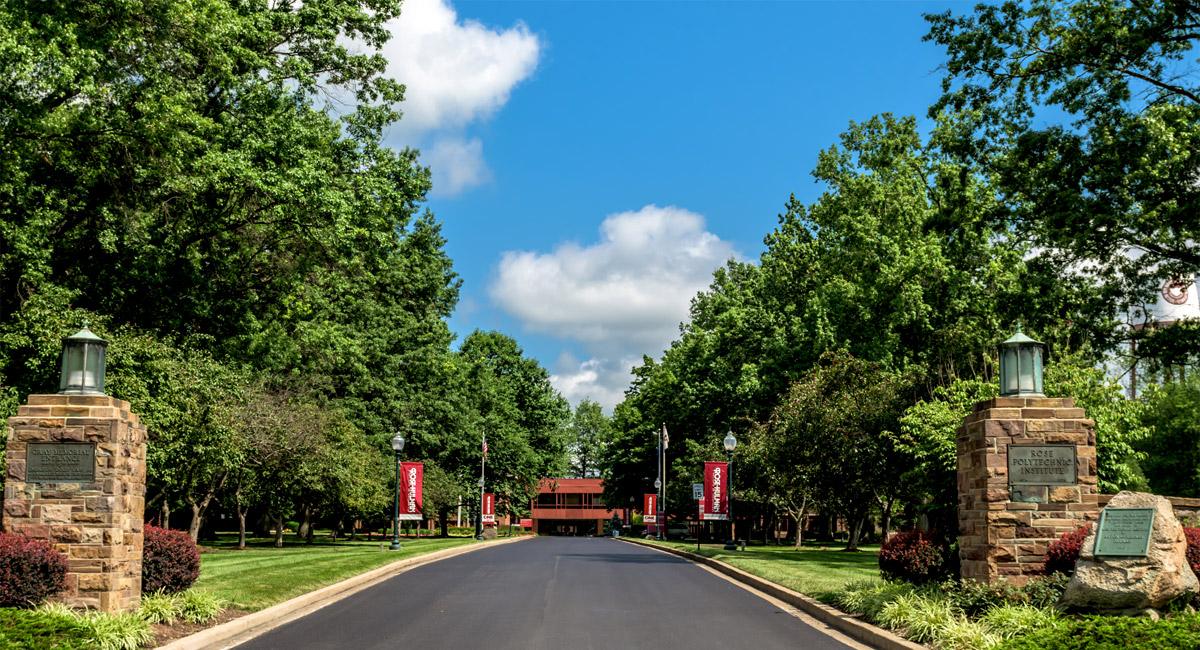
[{"x1": 655, "y1": 542, "x2": 880, "y2": 602}]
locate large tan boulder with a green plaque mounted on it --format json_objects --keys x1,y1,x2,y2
[{"x1": 1058, "y1": 492, "x2": 1200, "y2": 614}]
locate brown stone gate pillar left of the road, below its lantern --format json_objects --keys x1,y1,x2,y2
[{"x1": 4, "y1": 395, "x2": 146, "y2": 612}]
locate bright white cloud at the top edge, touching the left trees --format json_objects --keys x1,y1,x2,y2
[{"x1": 380, "y1": 0, "x2": 542, "y2": 133}]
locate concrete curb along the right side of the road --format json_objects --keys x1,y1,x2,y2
[{"x1": 617, "y1": 537, "x2": 929, "y2": 650}]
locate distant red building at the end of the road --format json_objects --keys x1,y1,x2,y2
[{"x1": 530, "y1": 479, "x2": 625, "y2": 535}]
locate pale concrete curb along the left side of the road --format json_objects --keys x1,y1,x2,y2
[{"x1": 157, "y1": 535, "x2": 534, "y2": 650}]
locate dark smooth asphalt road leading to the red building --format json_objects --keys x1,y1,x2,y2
[{"x1": 231, "y1": 537, "x2": 847, "y2": 650}]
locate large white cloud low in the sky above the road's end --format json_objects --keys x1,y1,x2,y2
[{"x1": 490, "y1": 205, "x2": 734, "y2": 408}]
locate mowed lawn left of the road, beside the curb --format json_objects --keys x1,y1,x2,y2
[{"x1": 194, "y1": 536, "x2": 484, "y2": 612}]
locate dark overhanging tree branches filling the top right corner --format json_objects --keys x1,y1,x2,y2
[{"x1": 926, "y1": 0, "x2": 1200, "y2": 360}]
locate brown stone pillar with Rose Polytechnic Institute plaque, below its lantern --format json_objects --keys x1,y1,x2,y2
[{"x1": 956, "y1": 397, "x2": 1099, "y2": 585}]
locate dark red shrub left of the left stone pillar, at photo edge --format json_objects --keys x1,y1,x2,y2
[{"x1": 0, "y1": 532, "x2": 67, "y2": 608}]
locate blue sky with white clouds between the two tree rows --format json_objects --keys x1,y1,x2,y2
[{"x1": 369, "y1": 0, "x2": 972, "y2": 408}]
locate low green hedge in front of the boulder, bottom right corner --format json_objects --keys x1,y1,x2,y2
[{"x1": 1000, "y1": 614, "x2": 1200, "y2": 650}]
